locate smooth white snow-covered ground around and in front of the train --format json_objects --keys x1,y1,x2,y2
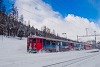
[{"x1": 0, "y1": 36, "x2": 100, "y2": 67}]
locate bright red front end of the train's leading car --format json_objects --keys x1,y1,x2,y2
[{"x1": 27, "y1": 37, "x2": 43, "y2": 52}]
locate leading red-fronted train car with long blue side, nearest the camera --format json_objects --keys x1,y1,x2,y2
[{"x1": 27, "y1": 36, "x2": 83, "y2": 53}]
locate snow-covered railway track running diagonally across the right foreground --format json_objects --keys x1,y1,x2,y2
[{"x1": 43, "y1": 53, "x2": 98, "y2": 67}]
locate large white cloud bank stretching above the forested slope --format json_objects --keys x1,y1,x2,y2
[{"x1": 16, "y1": 0, "x2": 100, "y2": 40}]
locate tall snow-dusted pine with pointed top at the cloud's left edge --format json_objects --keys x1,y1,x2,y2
[{"x1": 8, "y1": 4, "x2": 18, "y2": 37}]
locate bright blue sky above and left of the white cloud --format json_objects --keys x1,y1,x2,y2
[{"x1": 4, "y1": 0, "x2": 100, "y2": 21}]
